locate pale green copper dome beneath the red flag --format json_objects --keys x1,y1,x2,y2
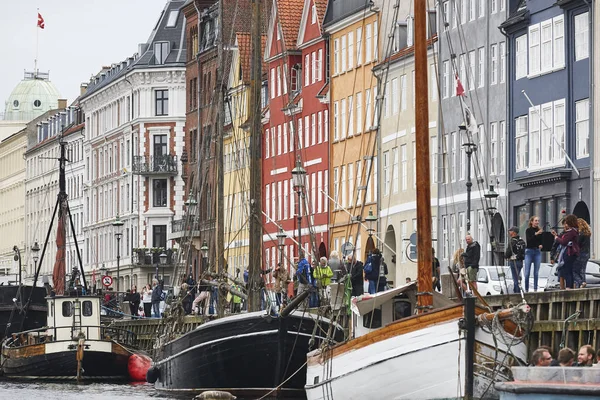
[{"x1": 4, "y1": 72, "x2": 60, "y2": 121}]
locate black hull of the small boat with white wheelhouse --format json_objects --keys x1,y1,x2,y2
[{"x1": 2, "y1": 341, "x2": 130, "y2": 381}]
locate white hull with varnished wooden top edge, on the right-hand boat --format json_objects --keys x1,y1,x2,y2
[{"x1": 306, "y1": 306, "x2": 526, "y2": 400}]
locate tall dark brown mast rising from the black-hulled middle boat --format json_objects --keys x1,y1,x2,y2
[{"x1": 247, "y1": 0, "x2": 262, "y2": 311}]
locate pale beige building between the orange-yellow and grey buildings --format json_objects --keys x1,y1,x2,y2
[{"x1": 375, "y1": 33, "x2": 438, "y2": 285}]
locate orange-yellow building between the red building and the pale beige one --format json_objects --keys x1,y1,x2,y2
[{"x1": 324, "y1": 2, "x2": 379, "y2": 261}]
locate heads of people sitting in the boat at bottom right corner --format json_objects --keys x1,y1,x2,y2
[{"x1": 530, "y1": 344, "x2": 600, "y2": 367}]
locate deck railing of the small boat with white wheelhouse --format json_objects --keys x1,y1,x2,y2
[{"x1": 5, "y1": 325, "x2": 137, "y2": 348}]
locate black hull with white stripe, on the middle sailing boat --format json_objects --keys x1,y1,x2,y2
[{"x1": 148, "y1": 311, "x2": 343, "y2": 396}]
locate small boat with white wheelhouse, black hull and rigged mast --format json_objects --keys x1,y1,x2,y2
[{"x1": 1, "y1": 138, "x2": 141, "y2": 381}]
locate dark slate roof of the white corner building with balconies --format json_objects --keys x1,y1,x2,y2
[{"x1": 81, "y1": 0, "x2": 187, "y2": 99}]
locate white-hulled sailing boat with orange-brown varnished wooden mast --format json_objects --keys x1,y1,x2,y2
[{"x1": 305, "y1": 0, "x2": 529, "y2": 400}]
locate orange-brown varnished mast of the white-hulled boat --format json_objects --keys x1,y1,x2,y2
[{"x1": 415, "y1": 0, "x2": 433, "y2": 313}]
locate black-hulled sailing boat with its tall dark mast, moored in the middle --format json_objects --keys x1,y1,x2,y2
[{"x1": 147, "y1": 1, "x2": 343, "y2": 396}]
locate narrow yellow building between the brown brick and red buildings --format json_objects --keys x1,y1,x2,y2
[{"x1": 223, "y1": 32, "x2": 264, "y2": 276}]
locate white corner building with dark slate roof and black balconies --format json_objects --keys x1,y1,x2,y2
[{"x1": 80, "y1": 0, "x2": 186, "y2": 291}]
